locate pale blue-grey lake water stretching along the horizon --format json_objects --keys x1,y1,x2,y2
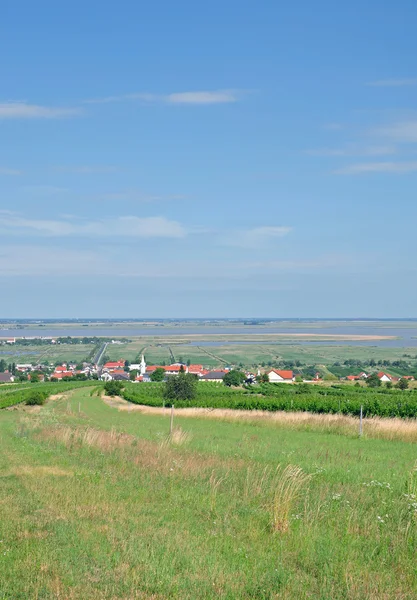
[{"x1": 0, "y1": 322, "x2": 417, "y2": 347}]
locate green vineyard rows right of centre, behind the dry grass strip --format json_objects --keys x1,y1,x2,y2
[{"x1": 122, "y1": 383, "x2": 417, "y2": 418}]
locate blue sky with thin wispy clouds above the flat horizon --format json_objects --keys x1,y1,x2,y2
[{"x1": 0, "y1": 0, "x2": 417, "y2": 318}]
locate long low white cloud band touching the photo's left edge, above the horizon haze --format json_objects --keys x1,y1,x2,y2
[{"x1": 0, "y1": 211, "x2": 186, "y2": 238}]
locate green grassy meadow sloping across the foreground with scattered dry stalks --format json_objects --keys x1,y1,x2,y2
[{"x1": 0, "y1": 388, "x2": 417, "y2": 600}]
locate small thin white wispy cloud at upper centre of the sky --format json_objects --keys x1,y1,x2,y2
[{"x1": 85, "y1": 90, "x2": 243, "y2": 105}]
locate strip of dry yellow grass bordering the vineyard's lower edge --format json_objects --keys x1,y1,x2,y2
[{"x1": 103, "y1": 397, "x2": 417, "y2": 442}]
